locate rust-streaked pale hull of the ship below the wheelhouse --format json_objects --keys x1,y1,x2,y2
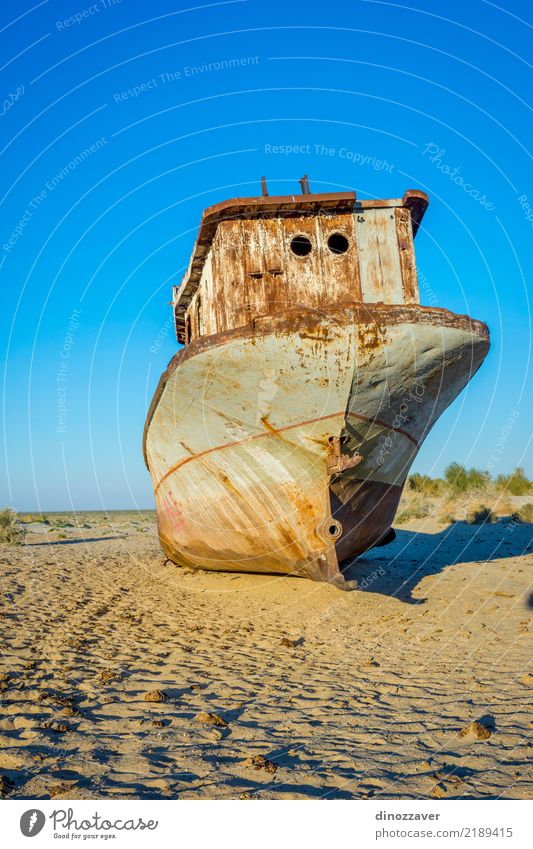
[{"x1": 144, "y1": 183, "x2": 489, "y2": 587}]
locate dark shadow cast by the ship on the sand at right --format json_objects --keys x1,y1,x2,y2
[{"x1": 343, "y1": 518, "x2": 533, "y2": 604}]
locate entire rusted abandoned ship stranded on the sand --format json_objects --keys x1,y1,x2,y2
[{"x1": 143, "y1": 177, "x2": 489, "y2": 588}]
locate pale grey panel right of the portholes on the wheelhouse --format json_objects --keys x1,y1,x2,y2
[{"x1": 357, "y1": 208, "x2": 404, "y2": 304}]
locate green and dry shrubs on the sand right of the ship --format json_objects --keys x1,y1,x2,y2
[{"x1": 396, "y1": 463, "x2": 533, "y2": 525}]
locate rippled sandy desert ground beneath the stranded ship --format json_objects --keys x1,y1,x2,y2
[{"x1": 0, "y1": 514, "x2": 533, "y2": 799}]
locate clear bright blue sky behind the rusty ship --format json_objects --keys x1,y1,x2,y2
[{"x1": 0, "y1": 0, "x2": 533, "y2": 510}]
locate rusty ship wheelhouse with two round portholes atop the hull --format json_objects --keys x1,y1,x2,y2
[{"x1": 173, "y1": 178, "x2": 428, "y2": 345}]
